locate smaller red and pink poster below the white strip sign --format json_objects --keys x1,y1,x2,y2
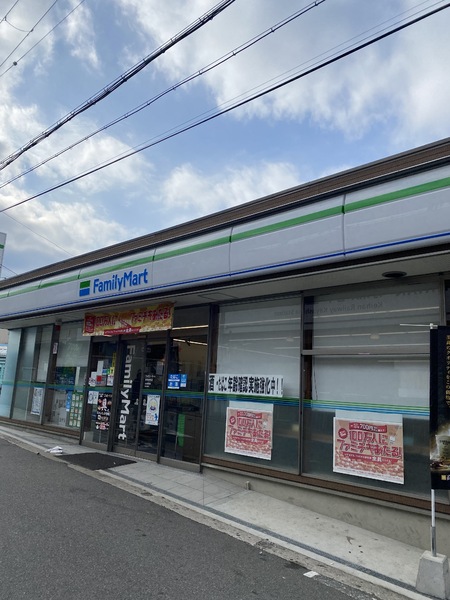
[{"x1": 225, "y1": 407, "x2": 273, "y2": 460}]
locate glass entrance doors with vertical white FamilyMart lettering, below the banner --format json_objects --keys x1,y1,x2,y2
[{"x1": 110, "y1": 318, "x2": 207, "y2": 464}]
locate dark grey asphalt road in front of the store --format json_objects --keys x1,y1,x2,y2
[{"x1": 0, "y1": 439, "x2": 400, "y2": 600}]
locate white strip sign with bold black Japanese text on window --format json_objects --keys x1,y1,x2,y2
[{"x1": 208, "y1": 373, "x2": 283, "y2": 398}]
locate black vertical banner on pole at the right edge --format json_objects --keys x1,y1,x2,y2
[{"x1": 430, "y1": 327, "x2": 450, "y2": 490}]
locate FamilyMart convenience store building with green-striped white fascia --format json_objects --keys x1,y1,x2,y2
[{"x1": 0, "y1": 139, "x2": 450, "y2": 554}]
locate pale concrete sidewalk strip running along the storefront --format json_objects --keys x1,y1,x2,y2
[{"x1": 0, "y1": 425, "x2": 438, "y2": 600}]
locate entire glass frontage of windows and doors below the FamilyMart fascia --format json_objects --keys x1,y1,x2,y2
[{"x1": 1, "y1": 276, "x2": 442, "y2": 499}]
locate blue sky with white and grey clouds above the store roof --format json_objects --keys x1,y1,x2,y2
[{"x1": 0, "y1": 0, "x2": 450, "y2": 278}]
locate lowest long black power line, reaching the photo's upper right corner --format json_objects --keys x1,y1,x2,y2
[{"x1": 0, "y1": 2, "x2": 450, "y2": 213}]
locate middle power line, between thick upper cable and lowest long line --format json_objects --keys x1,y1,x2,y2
[{"x1": 0, "y1": 0, "x2": 326, "y2": 189}]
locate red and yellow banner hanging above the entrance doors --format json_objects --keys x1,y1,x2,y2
[{"x1": 83, "y1": 303, "x2": 173, "y2": 335}]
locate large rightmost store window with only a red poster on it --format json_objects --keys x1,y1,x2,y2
[{"x1": 302, "y1": 283, "x2": 440, "y2": 495}]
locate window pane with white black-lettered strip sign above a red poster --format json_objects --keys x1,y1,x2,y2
[{"x1": 205, "y1": 297, "x2": 301, "y2": 472}]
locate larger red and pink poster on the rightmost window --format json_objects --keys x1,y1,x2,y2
[{"x1": 333, "y1": 418, "x2": 404, "y2": 484}]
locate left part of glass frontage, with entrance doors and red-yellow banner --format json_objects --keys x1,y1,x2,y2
[{"x1": 2, "y1": 302, "x2": 209, "y2": 465}]
